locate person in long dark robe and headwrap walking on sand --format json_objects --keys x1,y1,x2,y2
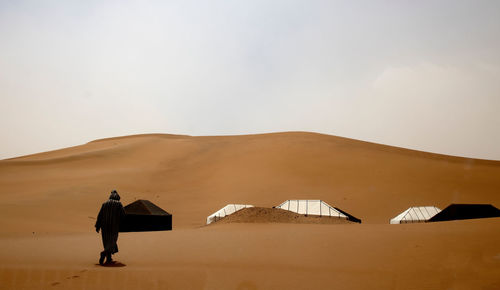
[{"x1": 95, "y1": 190, "x2": 125, "y2": 265}]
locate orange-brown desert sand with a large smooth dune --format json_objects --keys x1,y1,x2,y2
[{"x1": 0, "y1": 132, "x2": 500, "y2": 289}]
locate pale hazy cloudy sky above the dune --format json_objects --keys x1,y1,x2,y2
[{"x1": 0, "y1": 0, "x2": 500, "y2": 160}]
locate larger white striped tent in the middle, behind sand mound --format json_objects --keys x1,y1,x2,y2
[{"x1": 275, "y1": 199, "x2": 361, "y2": 223}]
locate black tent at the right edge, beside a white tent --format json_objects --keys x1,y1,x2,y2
[{"x1": 429, "y1": 204, "x2": 500, "y2": 222}]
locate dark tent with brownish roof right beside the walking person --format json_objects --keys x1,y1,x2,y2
[{"x1": 120, "y1": 199, "x2": 172, "y2": 232}]
